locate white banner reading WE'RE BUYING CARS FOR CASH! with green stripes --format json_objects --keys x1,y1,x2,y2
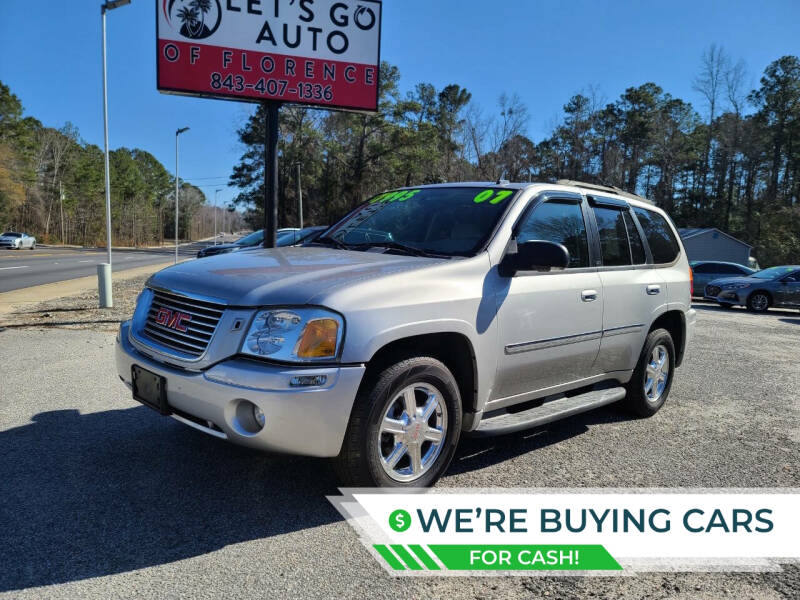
[{"x1": 329, "y1": 488, "x2": 800, "y2": 576}]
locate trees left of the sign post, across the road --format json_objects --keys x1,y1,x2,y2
[{"x1": 0, "y1": 81, "x2": 242, "y2": 246}]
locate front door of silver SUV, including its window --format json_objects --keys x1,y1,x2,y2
[{"x1": 491, "y1": 194, "x2": 604, "y2": 407}]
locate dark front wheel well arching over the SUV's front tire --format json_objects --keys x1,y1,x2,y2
[{"x1": 363, "y1": 333, "x2": 478, "y2": 412}]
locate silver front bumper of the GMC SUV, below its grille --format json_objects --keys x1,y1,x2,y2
[{"x1": 116, "y1": 321, "x2": 365, "y2": 456}]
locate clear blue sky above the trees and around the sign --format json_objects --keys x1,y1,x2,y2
[{"x1": 0, "y1": 0, "x2": 800, "y2": 211}]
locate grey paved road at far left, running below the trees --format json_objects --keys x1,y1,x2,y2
[{"x1": 0, "y1": 242, "x2": 228, "y2": 293}]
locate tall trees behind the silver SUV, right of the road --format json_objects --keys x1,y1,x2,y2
[{"x1": 229, "y1": 46, "x2": 800, "y2": 264}]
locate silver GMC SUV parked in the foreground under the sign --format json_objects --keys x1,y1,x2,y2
[{"x1": 116, "y1": 182, "x2": 695, "y2": 486}]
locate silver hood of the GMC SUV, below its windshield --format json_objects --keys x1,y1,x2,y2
[{"x1": 147, "y1": 246, "x2": 443, "y2": 306}]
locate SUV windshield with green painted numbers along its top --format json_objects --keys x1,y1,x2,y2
[{"x1": 319, "y1": 187, "x2": 515, "y2": 256}]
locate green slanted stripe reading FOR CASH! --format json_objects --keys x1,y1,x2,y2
[{"x1": 428, "y1": 544, "x2": 622, "y2": 571}]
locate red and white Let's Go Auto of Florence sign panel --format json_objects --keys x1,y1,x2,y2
[{"x1": 156, "y1": 0, "x2": 381, "y2": 111}]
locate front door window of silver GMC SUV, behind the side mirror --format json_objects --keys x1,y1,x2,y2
[{"x1": 517, "y1": 200, "x2": 589, "y2": 269}]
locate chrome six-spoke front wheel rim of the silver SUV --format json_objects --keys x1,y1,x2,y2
[{"x1": 378, "y1": 383, "x2": 447, "y2": 482}]
